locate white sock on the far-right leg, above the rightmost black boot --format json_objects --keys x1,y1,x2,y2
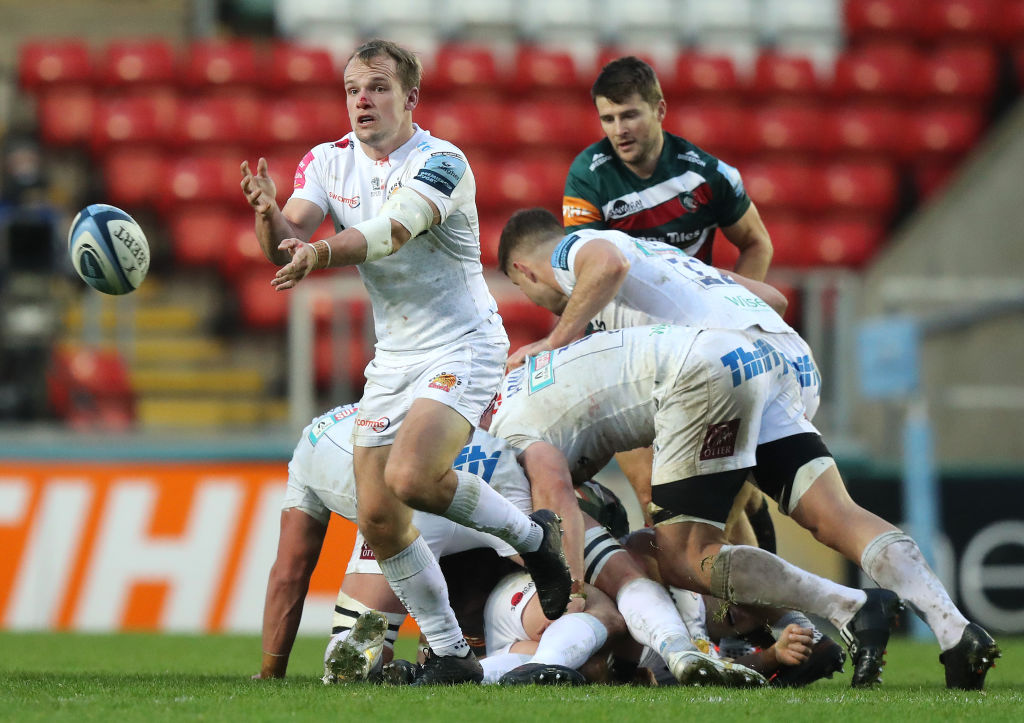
[{"x1": 860, "y1": 530, "x2": 968, "y2": 650}]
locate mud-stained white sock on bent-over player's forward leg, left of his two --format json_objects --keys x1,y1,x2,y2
[{"x1": 711, "y1": 545, "x2": 867, "y2": 628}]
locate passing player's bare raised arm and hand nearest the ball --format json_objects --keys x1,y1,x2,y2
[{"x1": 241, "y1": 158, "x2": 324, "y2": 266}]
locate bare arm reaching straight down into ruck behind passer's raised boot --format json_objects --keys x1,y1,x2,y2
[{"x1": 519, "y1": 441, "x2": 586, "y2": 612}]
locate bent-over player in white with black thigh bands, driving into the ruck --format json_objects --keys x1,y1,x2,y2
[{"x1": 490, "y1": 325, "x2": 998, "y2": 688}]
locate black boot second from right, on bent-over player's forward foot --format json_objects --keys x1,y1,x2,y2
[{"x1": 839, "y1": 588, "x2": 903, "y2": 688}]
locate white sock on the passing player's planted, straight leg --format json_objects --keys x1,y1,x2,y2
[{"x1": 378, "y1": 535, "x2": 469, "y2": 655}]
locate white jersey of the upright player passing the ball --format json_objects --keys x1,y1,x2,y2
[{"x1": 292, "y1": 126, "x2": 498, "y2": 351}]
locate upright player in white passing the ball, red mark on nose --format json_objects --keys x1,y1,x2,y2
[{"x1": 242, "y1": 40, "x2": 571, "y2": 685}]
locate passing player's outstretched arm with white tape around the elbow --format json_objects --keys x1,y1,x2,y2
[{"x1": 270, "y1": 186, "x2": 440, "y2": 291}]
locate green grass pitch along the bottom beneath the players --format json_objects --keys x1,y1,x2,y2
[{"x1": 0, "y1": 633, "x2": 1024, "y2": 723}]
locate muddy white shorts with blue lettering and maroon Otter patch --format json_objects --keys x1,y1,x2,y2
[{"x1": 651, "y1": 329, "x2": 817, "y2": 484}]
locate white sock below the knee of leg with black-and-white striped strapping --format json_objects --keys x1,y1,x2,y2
[{"x1": 615, "y1": 578, "x2": 696, "y2": 656}]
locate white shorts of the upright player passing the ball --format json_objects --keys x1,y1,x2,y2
[{"x1": 352, "y1": 321, "x2": 509, "y2": 446}]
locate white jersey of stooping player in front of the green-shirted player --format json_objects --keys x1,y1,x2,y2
[{"x1": 551, "y1": 229, "x2": 793, "y2": 333}]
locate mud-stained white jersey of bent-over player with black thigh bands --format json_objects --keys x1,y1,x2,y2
[{"x1": 489, "y1": 324, "x2": 700, "y2": 484}]
